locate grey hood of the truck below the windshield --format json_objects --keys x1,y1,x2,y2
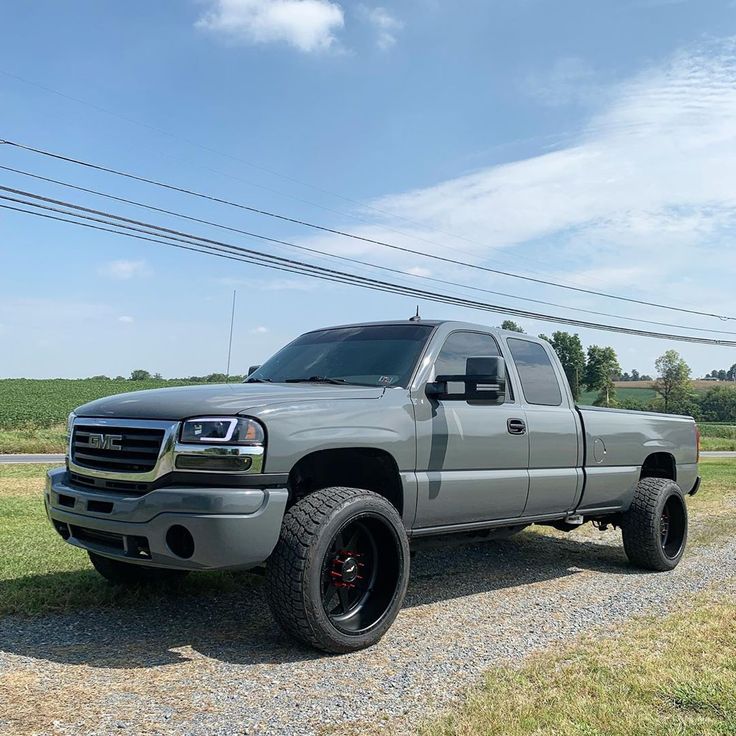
[{"x1": 74, "y1": 383, "x2": 385, "y2": 420}]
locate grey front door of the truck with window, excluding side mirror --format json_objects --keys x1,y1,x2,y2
[{"x1": 414, "y1": 330, "x2": 529, "y2": 528}]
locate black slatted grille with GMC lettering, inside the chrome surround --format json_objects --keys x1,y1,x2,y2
[{"x1": 72, "y1": 424, "x2": 164, "y2": 473}]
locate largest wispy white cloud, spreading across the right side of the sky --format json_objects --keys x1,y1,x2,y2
[{"x1": 292, "y1": 40, "x2": 736, "y2": 362}]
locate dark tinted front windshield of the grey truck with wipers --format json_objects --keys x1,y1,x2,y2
[{"x1": 247, "y1": 324, "x2": 433, "y2": 388}]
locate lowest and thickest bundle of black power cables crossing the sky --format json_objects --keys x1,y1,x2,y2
[{"x1": 5, "y1": 195, "x2": 736, "y2": 347}]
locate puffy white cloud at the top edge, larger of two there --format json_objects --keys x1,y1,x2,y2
[{"x1": 196, "y1": 0, "x2": 345, "y2": 52}]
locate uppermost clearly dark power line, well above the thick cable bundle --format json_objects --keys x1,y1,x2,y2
[{"x1": 0, "y1": 139, "x2": 736, "y2": 320}]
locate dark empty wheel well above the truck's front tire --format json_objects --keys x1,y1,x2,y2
[{"x1": 289, "y1": 447, "x2": 403, "y2": 514}]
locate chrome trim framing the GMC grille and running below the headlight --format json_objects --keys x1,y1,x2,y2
[{"x1": 67, "y1": 416, "x2": 265, "y2": 483}]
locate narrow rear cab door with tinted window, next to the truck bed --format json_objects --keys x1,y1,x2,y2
[{"x1": 506, "y1": 337, "x2": 583, "y2": 516}]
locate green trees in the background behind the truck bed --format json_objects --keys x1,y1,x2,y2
[{"x1": 501, "y1": 320, "x2": 736, "y2": 422}]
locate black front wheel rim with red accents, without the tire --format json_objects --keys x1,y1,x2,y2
[{"x1": 322, "y1": 515, "x2": 402, "y2": 635}]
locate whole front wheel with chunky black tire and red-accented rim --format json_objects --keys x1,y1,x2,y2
[{"x1": 266, "y1": 488, "x2": 409, "y2": 653}]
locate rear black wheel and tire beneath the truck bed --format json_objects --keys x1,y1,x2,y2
[{"x1": 621, "y1": 478, "x2": 687, "y2": 571}]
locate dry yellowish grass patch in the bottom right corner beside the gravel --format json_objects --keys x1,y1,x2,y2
[{"x1": 419, "y1": 595, "x2": 736, "y2": 736}]
